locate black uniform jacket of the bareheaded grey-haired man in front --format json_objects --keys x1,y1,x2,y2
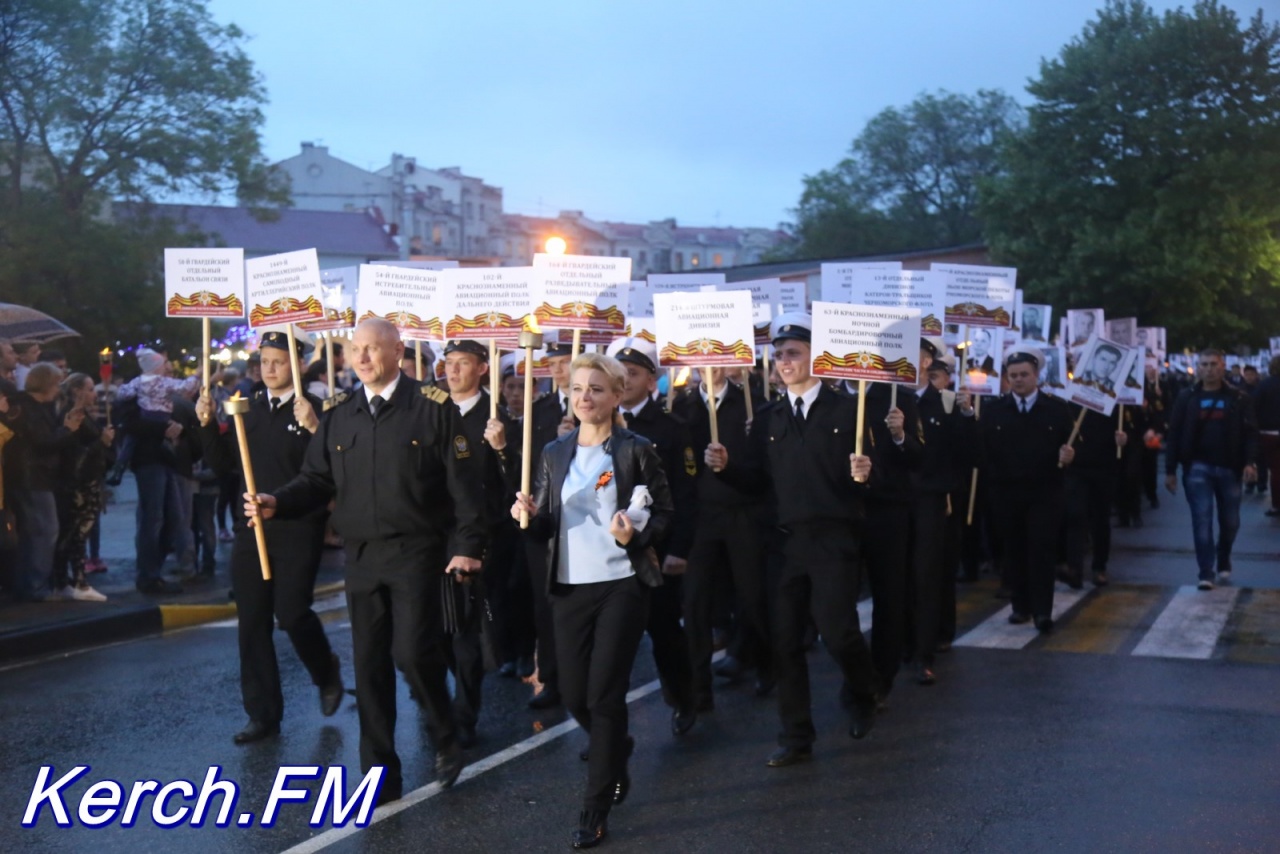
[{"x1": 274, "y1": 374, "x2": 488, "y2": 560}]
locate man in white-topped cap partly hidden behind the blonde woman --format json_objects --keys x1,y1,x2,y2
[{"x1": 608, "y1": 338, "x2": 698, "y2": 735}]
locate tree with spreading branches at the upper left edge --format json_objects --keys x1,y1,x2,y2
[{"x1": 0, "y1": 0, "x2": 288, "y2": 363}]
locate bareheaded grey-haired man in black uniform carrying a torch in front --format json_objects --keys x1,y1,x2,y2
[{"x1": 244, "y1": 319, "x2": 485, "y2": 803}]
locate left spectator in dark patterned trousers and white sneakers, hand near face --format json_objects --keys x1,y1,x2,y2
[{"x1": 51, "y1": 374, "x2": 115, "y2": 602}]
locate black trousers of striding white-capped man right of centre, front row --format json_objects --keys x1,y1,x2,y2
[{"x1": 773, "y1": 521, "x2": 879, "y2": 748}]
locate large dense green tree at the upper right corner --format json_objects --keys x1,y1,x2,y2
[{"x1": 982, "y1": 0, "x2": 1280, "y2": 346}]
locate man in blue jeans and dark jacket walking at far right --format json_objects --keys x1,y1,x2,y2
[{"x1": 1165, "y1": 348, "x2": 1258, "y2": 590}]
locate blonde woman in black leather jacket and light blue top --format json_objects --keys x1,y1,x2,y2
[{"x1": 511, "y1": 353, "x2": 673, "y2": 848}]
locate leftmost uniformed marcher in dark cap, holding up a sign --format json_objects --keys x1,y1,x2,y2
[{"x1": 196, "y1": 332, "x2": 342, "y2": 744}]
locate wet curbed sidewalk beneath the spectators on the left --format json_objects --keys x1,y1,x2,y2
[{"x1": 0, "y1": 474, "x2": 343, "y2": 666}]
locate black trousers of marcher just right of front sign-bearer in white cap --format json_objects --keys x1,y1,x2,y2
[{"x1": 863, "y1": 501, "x2": 911, "y2": 693}]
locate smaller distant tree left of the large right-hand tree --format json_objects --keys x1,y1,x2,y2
[{"x1": 773, "y1": 90, "x2": 1021, "y2": 257}]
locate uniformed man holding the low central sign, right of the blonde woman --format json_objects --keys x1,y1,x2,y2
[{"x1": 678, "y1": 353, "x2": 773, "y2": 711}]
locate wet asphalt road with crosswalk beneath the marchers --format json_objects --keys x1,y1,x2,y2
[{"x1": 0, "y1": 491, "x2": 1280, "y2": 854}]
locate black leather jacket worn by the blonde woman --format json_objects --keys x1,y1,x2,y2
[{"x1": 529, "y1": 426, "x2": 676, "y2": 593}]
